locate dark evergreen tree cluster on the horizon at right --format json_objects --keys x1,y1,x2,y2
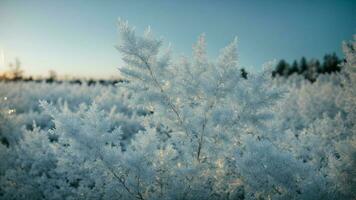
[{"x1": 272, "y1": 53, "x2": 342, "y2": 82}]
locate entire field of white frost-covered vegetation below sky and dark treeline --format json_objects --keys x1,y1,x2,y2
[{"x1": 0, "y1": 21, "x2": 356, "y2": 200}]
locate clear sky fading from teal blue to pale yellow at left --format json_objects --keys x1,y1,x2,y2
[{"x1": 0, "y1": 0, "x2": 356, "y2": 77}]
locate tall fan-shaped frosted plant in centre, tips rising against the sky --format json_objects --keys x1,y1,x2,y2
[{"x1": 118, "y1": 18, "x2": 279, "y2": 159}]
